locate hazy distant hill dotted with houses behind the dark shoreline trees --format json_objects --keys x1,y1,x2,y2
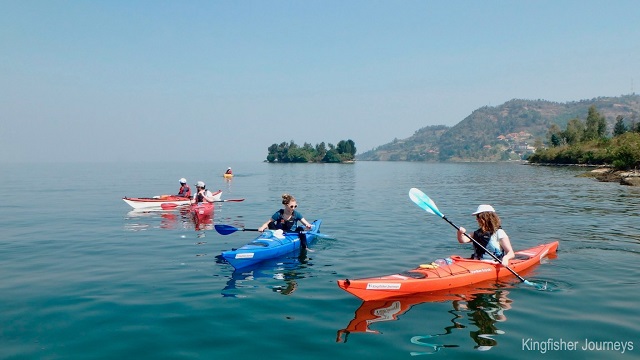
[{"x1": 356, "y1": 94, "x2": 640, "y2": 161}]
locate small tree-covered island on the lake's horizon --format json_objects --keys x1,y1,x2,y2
[{"x1": 267, "y1": 139, "x2": 356, "y2": 163}]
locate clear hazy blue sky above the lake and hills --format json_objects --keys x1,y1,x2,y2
[{"x1": 0, "y1": 0, "x2": 640, "y2": 163}]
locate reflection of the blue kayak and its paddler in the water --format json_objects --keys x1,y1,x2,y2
[{"x1": 216, "y1": 250, "x2": 313, "y2": 297}]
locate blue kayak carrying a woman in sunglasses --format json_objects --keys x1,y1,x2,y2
[{"x1": 222, "y1": 220, "x2": 322, "y2": 269}]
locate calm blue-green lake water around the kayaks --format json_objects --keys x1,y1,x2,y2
[{"x1": 0, "y1": 162, "x2": 640, "y2": 360}]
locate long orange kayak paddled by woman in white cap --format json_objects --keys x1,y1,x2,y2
[{"x1": 338, "y1": 241, "x2": 558, "y2": 301}]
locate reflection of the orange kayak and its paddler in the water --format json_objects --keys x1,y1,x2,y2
[{"x1": 336, "y1": 283, "x2": 512, "y2": 355}]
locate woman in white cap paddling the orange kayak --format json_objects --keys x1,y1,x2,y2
[{"x1": 458, "y1": 205, "x2": 515, "y2": 266}]
